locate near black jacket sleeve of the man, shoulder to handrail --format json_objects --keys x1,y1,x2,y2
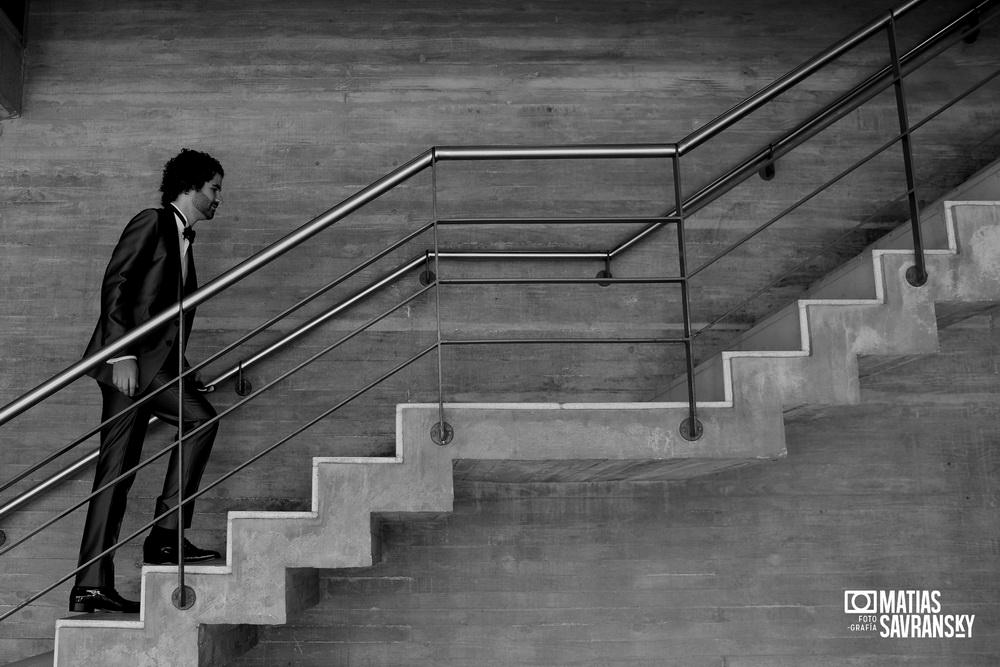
[{"x1": 101, "y1": 209, "x2": 157, "y2": 355}]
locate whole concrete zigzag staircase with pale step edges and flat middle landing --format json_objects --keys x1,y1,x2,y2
[{"x1": 48, "y1": 164, "x2": 1000, "y2": 665}]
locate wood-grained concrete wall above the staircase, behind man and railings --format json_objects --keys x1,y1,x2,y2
[{"x1": 0, "y1": 0, "x2": 998, "y2": 656}]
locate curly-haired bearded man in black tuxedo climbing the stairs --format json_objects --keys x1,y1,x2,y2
[{"x1": 69, "y1": 148, "x2": 224, "y2": 613}]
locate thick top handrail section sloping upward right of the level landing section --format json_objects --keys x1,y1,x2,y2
[{"x1": 677, "y1": 0, "x2": 925, "y2": 156}]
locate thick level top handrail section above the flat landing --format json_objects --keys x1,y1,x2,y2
[{"x1": 431, "y1": 145, "x2": 676, "y2": 160}]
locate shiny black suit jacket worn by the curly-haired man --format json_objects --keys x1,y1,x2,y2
[{"x1": 84, "y1": 207, "x2": 198, "y2": 392}]
